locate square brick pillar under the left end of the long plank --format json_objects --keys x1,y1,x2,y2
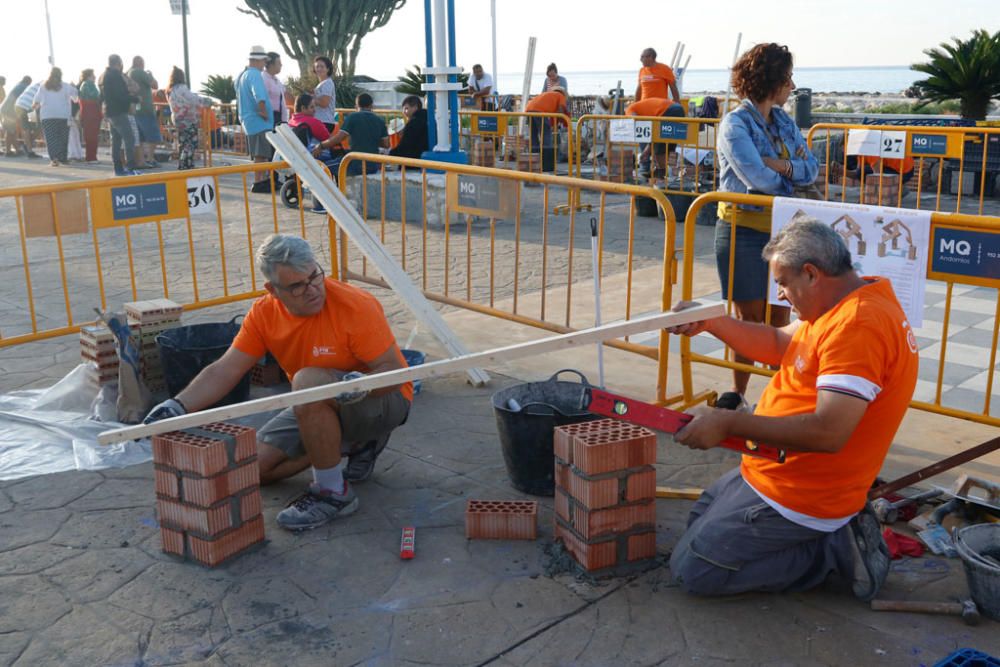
[{"x1": 153, "y1": 423, "x2": 264, "y2": 567}]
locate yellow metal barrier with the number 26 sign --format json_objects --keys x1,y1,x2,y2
[{"x1": 574, "y1": 114, "x2": 719, "y2": 197}]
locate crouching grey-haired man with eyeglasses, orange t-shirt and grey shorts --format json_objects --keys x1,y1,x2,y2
[{"x1": 145, "y1": 234, "x2": 413, "y2": 530}]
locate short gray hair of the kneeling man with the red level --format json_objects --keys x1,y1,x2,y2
[{"x1": 761, "y1": 220, "x2": 853, "y2": 276}]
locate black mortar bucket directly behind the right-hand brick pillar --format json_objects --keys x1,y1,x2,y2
[{"x1": 493, "y1": 368, "x2": 599, "y2": 496}]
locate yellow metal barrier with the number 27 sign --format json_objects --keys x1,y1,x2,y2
[{"x1": 807, "y1": 123, "x2": 1000, "y2": 215}]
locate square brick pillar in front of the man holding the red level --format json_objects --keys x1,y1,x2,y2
[{"x1": 553, "y1": 419, "x2": 656, "y2": 572}]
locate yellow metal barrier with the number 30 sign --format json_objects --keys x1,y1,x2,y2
[{"x1": 0, "y1": 162, "x2": 337, "y2": 348}]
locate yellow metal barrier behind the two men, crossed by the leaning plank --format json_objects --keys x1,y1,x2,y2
[{"x1": 338, "y1": 153, "x2": 676, "y2": 396}]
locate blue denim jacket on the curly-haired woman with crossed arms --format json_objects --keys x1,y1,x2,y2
[{"x1": 718, "y1": 100, "x2": 819, "y2": 196}]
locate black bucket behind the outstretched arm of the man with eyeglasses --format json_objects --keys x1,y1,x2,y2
[{"x1": 156, "y1": 316, "x2": 250, "y2": 407}]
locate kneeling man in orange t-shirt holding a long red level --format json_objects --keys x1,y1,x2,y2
[{"x1": 670, "y1": 221, "x2": 918, "y2": 601}]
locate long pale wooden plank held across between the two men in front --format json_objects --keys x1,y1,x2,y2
[{"x1": 97, "y1": 302, "x2": 726, "y2": 445}]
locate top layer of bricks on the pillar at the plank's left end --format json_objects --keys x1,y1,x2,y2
[{"x1": 153, "y1": 423, "x2": 257, "y2": 477}]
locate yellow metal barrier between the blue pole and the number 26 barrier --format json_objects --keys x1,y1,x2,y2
[{"x1": 459, "y1": 111, "x2": 575, "y2": 176}]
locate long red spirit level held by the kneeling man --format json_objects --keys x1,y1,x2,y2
[{"x1": 580, "y1": 387, "x2": 785, "y2": 463}]
